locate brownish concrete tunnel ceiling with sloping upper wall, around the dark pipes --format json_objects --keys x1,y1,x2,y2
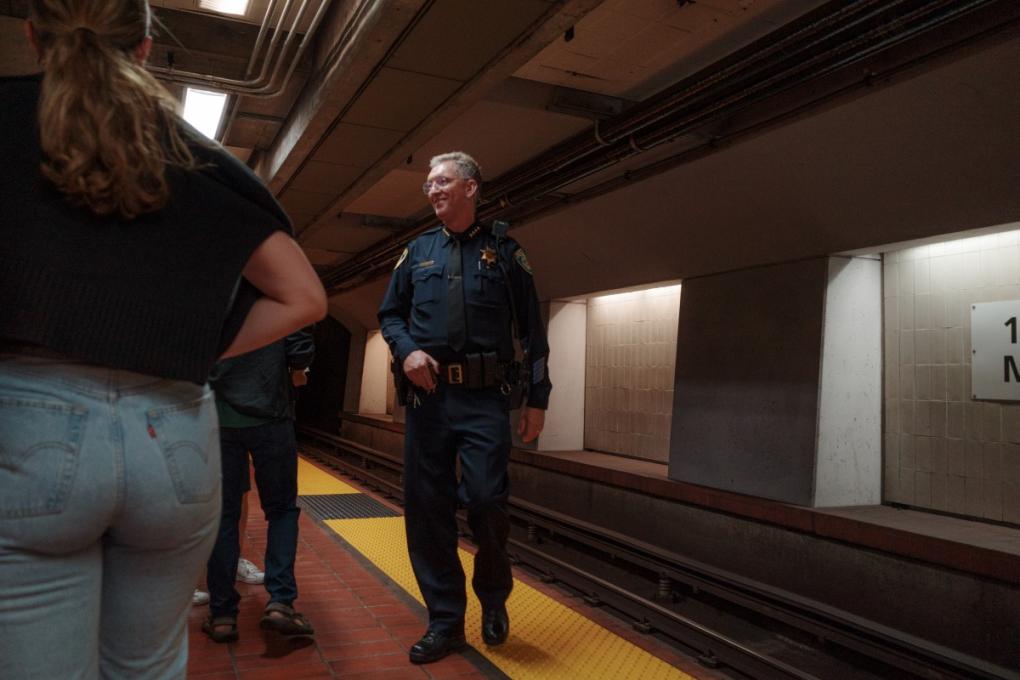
[{"x1": 0, "y1": 0, "x2": 1020, "y2": 327}]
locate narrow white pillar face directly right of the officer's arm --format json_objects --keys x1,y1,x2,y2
[{"x1": 539, "y1": 301, "x2": 588, "y2": 451}]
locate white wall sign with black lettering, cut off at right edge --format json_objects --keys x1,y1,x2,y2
[{"x1": 970, "y1": 300, "x2": 1020, "y2": 402}]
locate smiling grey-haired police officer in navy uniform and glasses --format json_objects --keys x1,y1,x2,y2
[{"x1": 378, "y1": 152, "x2": 552, "y2": 664}]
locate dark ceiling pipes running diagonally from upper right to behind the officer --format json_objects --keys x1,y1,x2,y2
[{"x1": 322, "y1": 0, "x2": 1003, "y2": 293}]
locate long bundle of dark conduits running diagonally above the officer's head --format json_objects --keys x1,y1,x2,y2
[{"x1": 322, "y1": 0, "x2": 1000, "y2": 292}]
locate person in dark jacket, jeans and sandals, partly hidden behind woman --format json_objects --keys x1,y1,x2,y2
[{"x1": 202, "y1": 330, "x2": 315, "y2": 642}]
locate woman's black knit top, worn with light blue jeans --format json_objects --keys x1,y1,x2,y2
[{"x1": 0, "y1": 75, "x2": 291, "y2": 383}]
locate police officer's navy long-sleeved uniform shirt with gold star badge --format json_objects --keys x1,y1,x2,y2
[{"x1": 378, "y1": 224, "x2": 552, "y2": 409}]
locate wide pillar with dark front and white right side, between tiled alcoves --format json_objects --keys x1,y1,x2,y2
[{"x1": 669, "y1": 258, "x2": 881, "y2": 507}]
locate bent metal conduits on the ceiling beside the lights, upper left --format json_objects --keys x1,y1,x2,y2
[{"x1": 149, "y1": 0, "x2": 334, "y2": 98}]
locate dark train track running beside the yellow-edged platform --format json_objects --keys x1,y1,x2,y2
[{"x1": 299, "y1": 426, "x2": 1020, "y2": 680}]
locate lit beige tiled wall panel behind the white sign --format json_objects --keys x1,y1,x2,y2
[{"x1": 882, "y1": 230, "x2": 1020, "y2": 524}]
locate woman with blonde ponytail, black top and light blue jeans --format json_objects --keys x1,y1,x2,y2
[{"x1": 0, "y1": 0, "x2": 325, "y2": 679}]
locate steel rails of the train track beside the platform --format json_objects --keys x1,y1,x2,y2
[{"x1": 299, "y1": 426, "x2": 1020, "y2": 680}]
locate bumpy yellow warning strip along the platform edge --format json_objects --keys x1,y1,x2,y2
[{"x1": 325, "y1": 517, "x2": 693, "y2": 680}]
